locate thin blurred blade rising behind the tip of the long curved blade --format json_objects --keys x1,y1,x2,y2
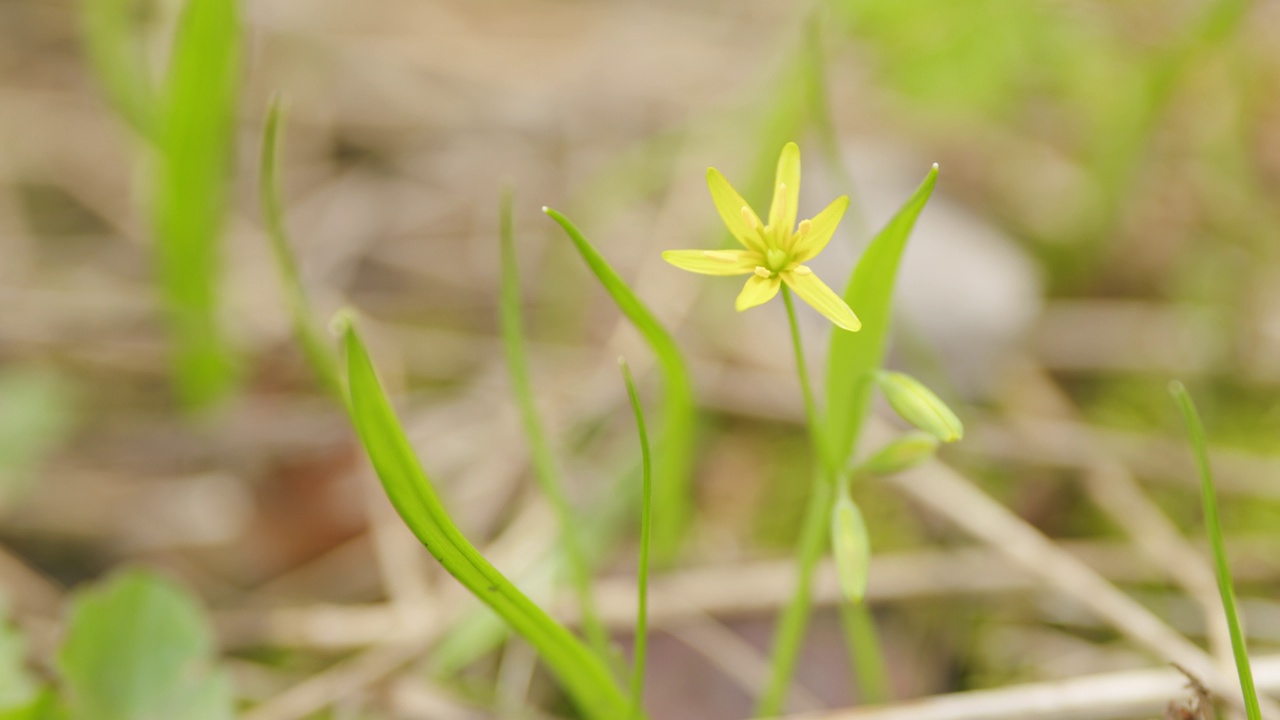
[{"x1": 259, "y1": 95, "x2": 342, "y2": 397}]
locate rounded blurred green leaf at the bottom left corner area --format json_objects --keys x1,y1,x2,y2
[{"x1": 58, "y1": 570, "x2": 234, "y2": 720}]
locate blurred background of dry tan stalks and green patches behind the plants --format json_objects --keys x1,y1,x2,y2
[{"x1": 0, "y1": 0, "x2": 1280, "y2": 720}]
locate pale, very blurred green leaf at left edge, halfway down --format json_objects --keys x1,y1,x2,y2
[{"x1": 0, "y1": 368, "x2": 74, "y2": 509}]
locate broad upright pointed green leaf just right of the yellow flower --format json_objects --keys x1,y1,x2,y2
[{"x1": 826, "y1": 165, "x2": 938, "y2": 465}]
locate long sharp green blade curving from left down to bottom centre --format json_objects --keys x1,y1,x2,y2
[{"x1": 338, "y1": 318, "x2": 631, "y2": 720}]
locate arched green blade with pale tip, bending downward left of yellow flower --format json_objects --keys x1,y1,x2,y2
[{"x1": 543, "y1": 208, "x2": 696, "y2": 562}]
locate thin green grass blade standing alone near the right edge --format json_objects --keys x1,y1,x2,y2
[{"x1": 1169, "y1": 382, "x2": 1262, "y2": 720}]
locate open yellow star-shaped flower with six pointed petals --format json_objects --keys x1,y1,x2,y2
[{"x1": 662, "y1": 142, "x2": 863, "y2": 332}]
